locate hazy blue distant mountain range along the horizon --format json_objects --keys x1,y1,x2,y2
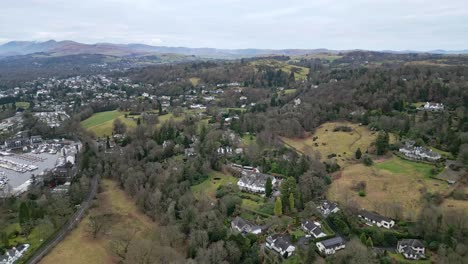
[{"x1": 0, "y1": 40, "x2": 468, "y2": 58}]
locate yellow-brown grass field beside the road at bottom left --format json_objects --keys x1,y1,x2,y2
[{"x1": 41, "y1": 180, "x2": 157, "y2": 264}]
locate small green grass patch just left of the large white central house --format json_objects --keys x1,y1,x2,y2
[{"x1": 191, "y1": 171, "x2": 238, "y2": 201}]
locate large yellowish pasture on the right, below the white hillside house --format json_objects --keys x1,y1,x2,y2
[{"x1": 327, "y1": 156, "x2": 450, "y2": 220}]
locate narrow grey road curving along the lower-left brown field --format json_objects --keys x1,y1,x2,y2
[{"x1": 27, "y1": 176, "x2": 98, "y2": 264}]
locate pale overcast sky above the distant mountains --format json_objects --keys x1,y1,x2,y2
[{"x1": 0, "y1": 0, "x2": 468, "y2": 51}]
